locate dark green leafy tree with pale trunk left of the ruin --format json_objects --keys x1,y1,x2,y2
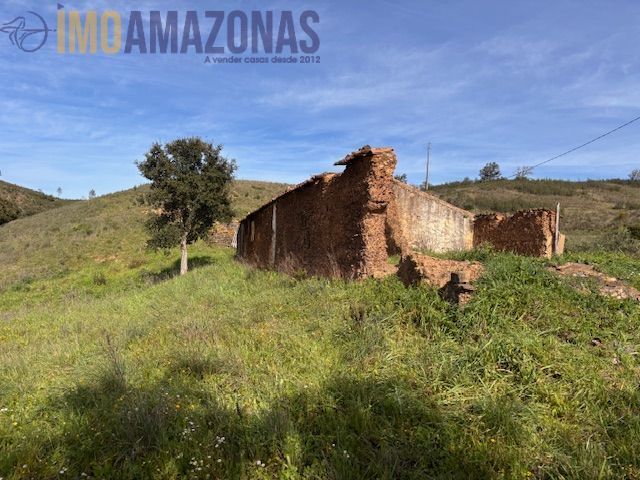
[{"x1": 137, "y1": 138, "x2": 236, "y2": 275}]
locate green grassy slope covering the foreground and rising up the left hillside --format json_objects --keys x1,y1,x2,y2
[{"x1": 0, "y1": 178, "x2": 640, "y2": 479}]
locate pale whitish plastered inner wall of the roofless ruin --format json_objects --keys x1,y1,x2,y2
[{"x1": 393, "y1": 180, "x2": 473, "y2": 253}]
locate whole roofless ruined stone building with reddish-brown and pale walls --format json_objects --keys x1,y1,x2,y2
[{"x1": 237, "y1": 147, "x2": 555, "y2": 278}]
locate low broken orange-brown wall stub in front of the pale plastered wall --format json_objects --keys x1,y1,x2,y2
[{"x1": 398, "y1": 254, "x2": 484, "y2": 304}]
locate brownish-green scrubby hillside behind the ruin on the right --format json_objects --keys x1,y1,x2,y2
[{"x1": 430, "y1": 180, "x2": 640, "y2": 250}]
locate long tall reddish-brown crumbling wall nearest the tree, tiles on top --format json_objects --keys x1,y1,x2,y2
[{"x1": 237, "y1": 147, "x2": 396, "y2": 278}]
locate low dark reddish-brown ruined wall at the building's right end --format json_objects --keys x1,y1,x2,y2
[{"x1": 473, "y1": 209, "x2": 564, "y2": 257}]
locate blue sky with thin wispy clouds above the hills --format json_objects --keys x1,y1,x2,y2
[{"x1": 0, "y1": 0, "x2": 640, "y2": 197}]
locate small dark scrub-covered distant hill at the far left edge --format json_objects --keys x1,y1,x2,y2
[{"x1": 0, "y1": 181, "x2": 69, "y2": 225}]
